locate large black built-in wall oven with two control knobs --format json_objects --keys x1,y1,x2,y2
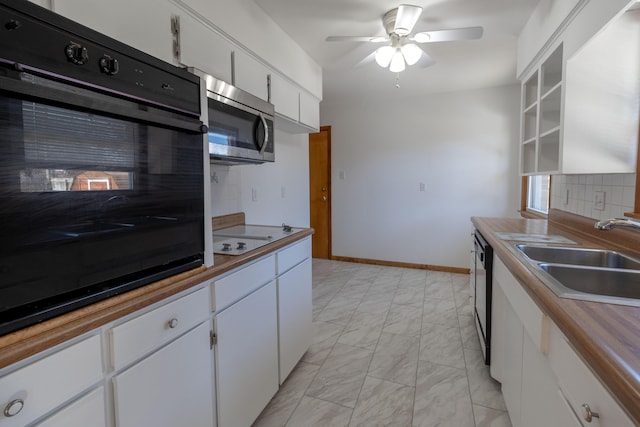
[{"x1": 0, "y1": 0, "x2": 206, "y2": 334}]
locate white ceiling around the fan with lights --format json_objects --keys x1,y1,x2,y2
[{"x1": 254, "y1": 0, "x2": 539, "y2": 103}]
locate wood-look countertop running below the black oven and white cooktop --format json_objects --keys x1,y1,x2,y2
[{"x1": 0, "y1": 229, "x2": 313, "y2": 369}]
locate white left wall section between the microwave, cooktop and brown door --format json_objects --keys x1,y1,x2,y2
[{"x1": 211, "y1": 129, "x2": 309, "y2": 227}]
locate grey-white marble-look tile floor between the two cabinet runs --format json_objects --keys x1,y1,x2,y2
[{"x1": 254, "y1": 259, "x2": 511, "y2": 427}]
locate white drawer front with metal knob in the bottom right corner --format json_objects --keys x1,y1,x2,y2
[{"x1": 549, "y1": 325, "x2": 634, "y2": 427}]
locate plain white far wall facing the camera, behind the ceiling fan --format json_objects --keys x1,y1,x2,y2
[{"x1": 320, "y1": 86, "x2": 520, "y2": 268}]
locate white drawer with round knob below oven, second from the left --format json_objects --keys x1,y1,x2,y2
[{"x1": 110, "y1": 287, "x2": 210, "y2": 370}]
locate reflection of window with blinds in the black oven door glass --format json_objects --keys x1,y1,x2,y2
[{"x1": 17, "y1": 100, "x2": 138, "y2": 193}]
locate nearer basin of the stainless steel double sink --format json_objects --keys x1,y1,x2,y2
[{"x1": 540, "y1": 264, "x2": 640, "y2": 304}]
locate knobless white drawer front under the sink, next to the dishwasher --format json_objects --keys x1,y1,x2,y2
[{"x1": 493, "y1": 258, "x2": 550, "y2": 353}]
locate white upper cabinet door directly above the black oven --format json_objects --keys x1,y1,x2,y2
[{"x1": 53, "y1": 0, "x2": 178, "y2": 63}]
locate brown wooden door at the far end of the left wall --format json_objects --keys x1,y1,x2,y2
[{"x1": 309, "y1": 126, "x2": 331, "y2": 259}]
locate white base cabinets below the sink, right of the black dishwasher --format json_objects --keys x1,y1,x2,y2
[{"x1": 491, "y1": 258, "x2": 634, "y2": 427}]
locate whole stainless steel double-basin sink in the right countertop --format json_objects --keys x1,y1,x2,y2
[{"x1": 513, "y1": 244, "x2": 640, "y2": 307}]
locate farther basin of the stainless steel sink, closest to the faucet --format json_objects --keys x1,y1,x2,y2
[{"x1": 516, "y1": 245, "x2": 640, "y2": 270}]
